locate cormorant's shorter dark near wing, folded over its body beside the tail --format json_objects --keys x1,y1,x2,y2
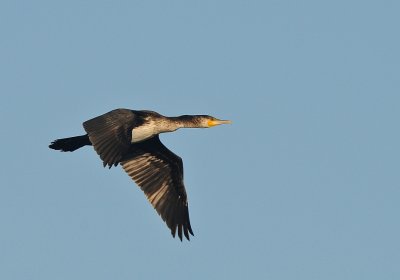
[{"x1": 83, "y1": 109, "x2": 143, "y2": 168}]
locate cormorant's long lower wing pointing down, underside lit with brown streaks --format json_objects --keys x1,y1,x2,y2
[{"x1": 121, "y1": 135, "x2": 193, "y2": 240}]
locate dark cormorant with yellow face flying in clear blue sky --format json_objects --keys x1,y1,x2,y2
[{"x1": 49, "y1": 109, "x2": 231, "y2": 241}]
